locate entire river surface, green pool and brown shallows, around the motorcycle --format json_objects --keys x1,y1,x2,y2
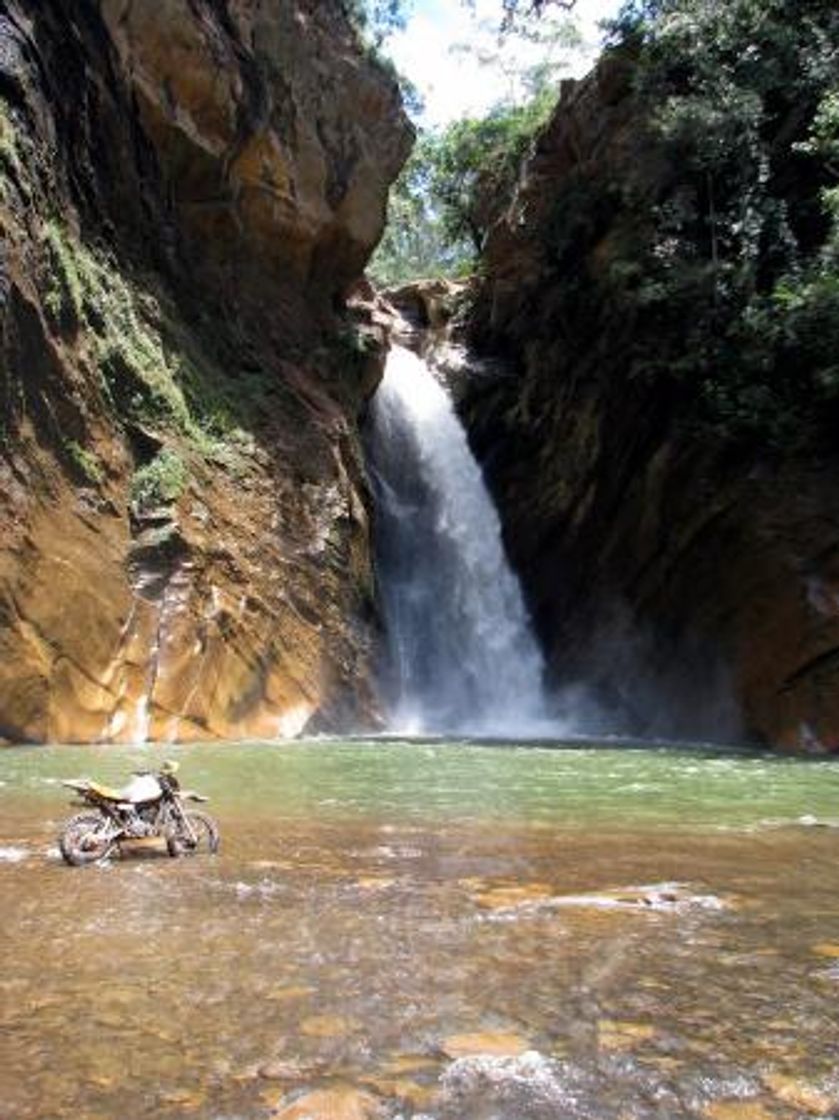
[{"x1": 0, "y1": 741, "x2": 839, "y2": 1120}]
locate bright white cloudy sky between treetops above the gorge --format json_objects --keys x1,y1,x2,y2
[{"x1": 386, "y1": 0, "x2": 619, "y2": 125}]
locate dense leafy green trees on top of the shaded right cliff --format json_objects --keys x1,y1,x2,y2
[{"x1": 560, "y1": 0, "x2": 839, "y2": 448}]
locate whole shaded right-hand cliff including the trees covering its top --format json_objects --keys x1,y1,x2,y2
[{"x1": 460, "y1": 0, "x2": 839, "y2": 749}]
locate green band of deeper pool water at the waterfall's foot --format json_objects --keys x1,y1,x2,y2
[{"x1": 6, "y1": 740, "x2": 839, "y2": 829}]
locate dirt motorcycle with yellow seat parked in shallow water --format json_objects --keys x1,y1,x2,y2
[{"x1": 58, "y1": 762, "x2": 220, "y2": 867}]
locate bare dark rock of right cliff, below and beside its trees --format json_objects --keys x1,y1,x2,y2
[{"x1": 464, "y1": 56, "x2": 839, "y2": 749}]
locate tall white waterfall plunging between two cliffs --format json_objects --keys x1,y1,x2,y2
[{"x1": 369, "y1": 347, "x2": 548, "y2": 736}]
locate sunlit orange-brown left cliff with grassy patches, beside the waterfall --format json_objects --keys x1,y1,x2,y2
[{"x1": 0, "y1": 0, "x2": 411, "y2": 741}]
